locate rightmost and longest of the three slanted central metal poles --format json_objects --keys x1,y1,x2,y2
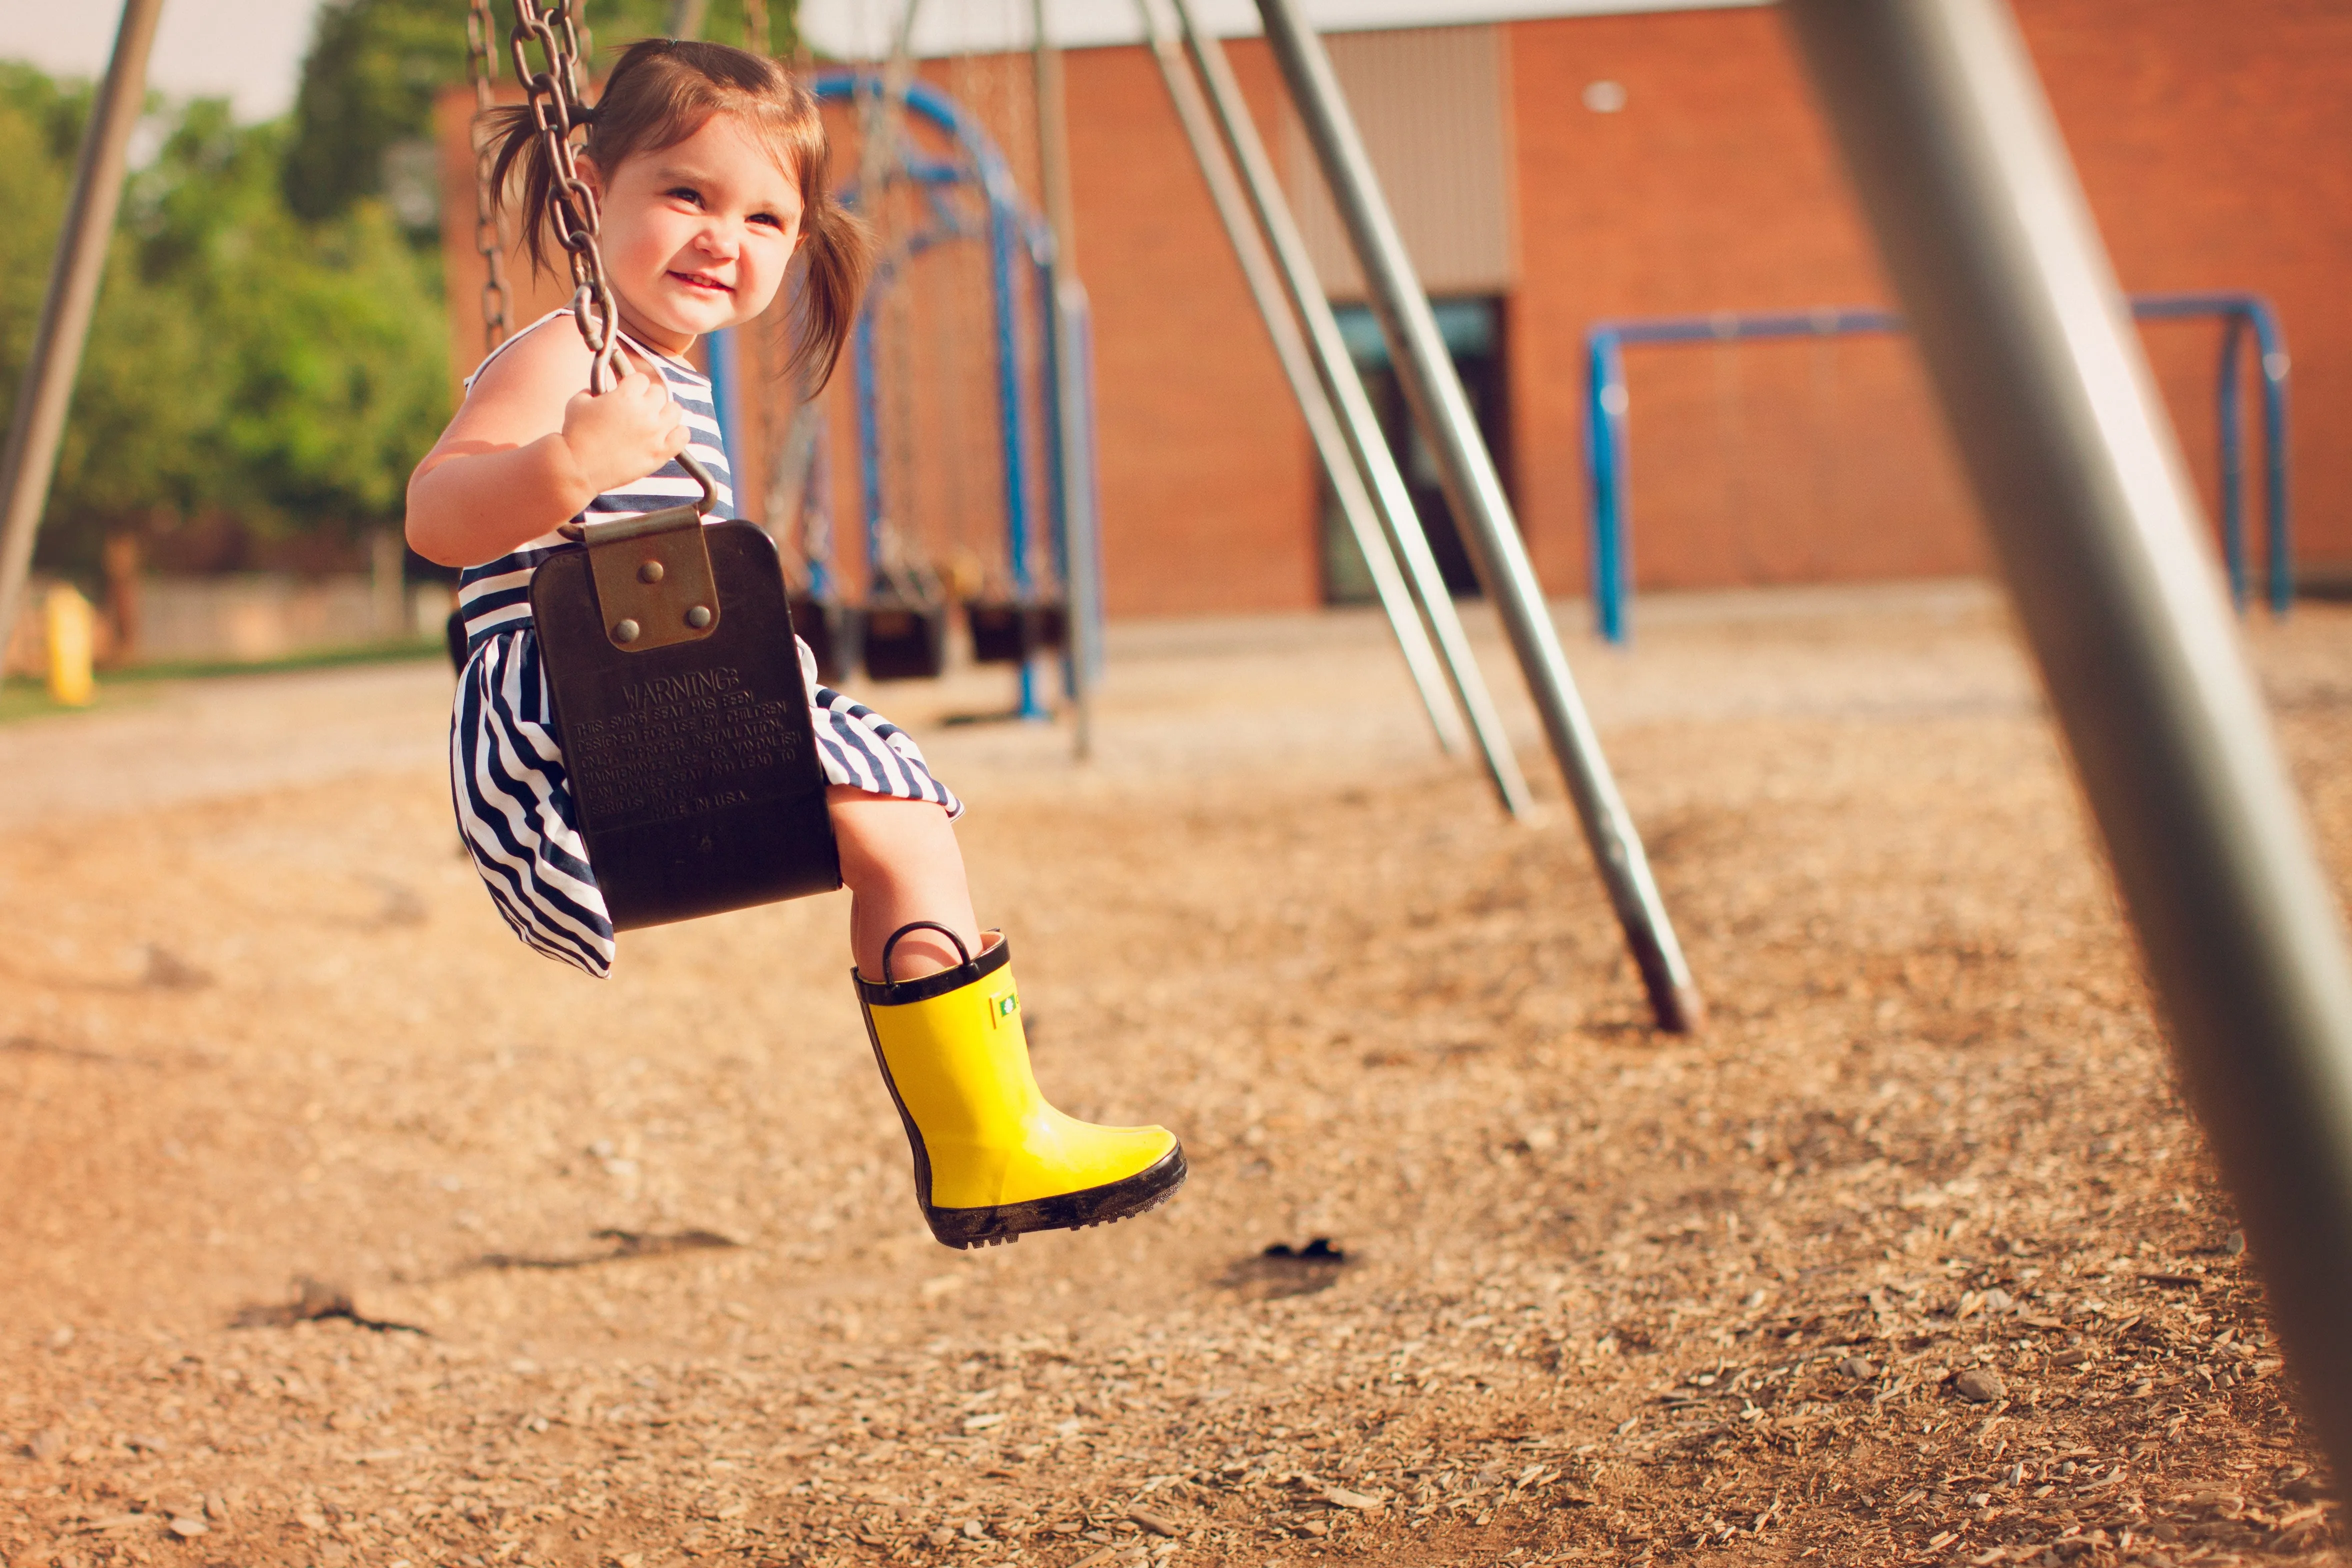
[{"x1": 1258, "y1": 0, "x2": 1705, "y2": 1034}]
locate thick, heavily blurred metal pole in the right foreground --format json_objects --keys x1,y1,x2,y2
[{"x1": 1783, "y1": 0, "x2": 2352, "y2": 1478}]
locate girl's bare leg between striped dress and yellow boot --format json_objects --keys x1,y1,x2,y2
[{"x1": 826, "y1": 785, "x2": 981, "y2": 980}]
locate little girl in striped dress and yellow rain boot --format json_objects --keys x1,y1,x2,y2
[{"x1": 407, "y1": 40, "x2": 1186, "y2": 1246}]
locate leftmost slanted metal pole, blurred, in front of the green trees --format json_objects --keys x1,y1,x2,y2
[{"x1": 0, "y1": 0, "x2": 162, "y2": 668}]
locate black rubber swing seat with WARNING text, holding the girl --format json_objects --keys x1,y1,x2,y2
[{"x1": 532, "y1": 506, "x2": 842, "y2": 931}]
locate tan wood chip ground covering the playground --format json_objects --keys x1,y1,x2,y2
[{"x1": 0, "y1": 588, "x2": 2352, "y2": 1568}]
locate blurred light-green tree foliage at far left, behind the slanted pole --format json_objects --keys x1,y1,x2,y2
[{"x1": 0, "y1": 66, "x2": 449, "y2": 569}]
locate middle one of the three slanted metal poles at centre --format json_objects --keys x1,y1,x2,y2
[{"x1": 1162, "y1": 0, "x2": 1534, "y2": 816}]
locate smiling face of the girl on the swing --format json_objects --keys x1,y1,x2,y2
[{"x1": 581, "y1": 115, "x2": 800, "y2": 352}]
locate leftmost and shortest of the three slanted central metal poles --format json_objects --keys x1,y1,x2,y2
[{"x1": 1136, "y1": 0, "x2": 1458, "y2": 762}]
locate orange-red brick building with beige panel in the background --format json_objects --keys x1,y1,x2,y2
[{"x1": 444, "y1": 0, "x2": 2352, "y2": 616}]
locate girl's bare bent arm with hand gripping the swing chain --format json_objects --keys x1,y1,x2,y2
[{"x1": 407, "y1": 322, "x2": 687, "y2": 566}]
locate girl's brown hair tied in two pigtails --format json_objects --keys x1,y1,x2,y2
[{"x1": 492, "y1": 38, "x2": 872, "y2": 395}]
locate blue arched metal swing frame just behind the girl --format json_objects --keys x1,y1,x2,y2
[{"x1": 786, "y1": 68, "x2": 1100, "y2": 720}]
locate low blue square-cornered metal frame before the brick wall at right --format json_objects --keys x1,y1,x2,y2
[{"x1": 1585, "y1": 294, "x2": 2296, "y2": 642}]
